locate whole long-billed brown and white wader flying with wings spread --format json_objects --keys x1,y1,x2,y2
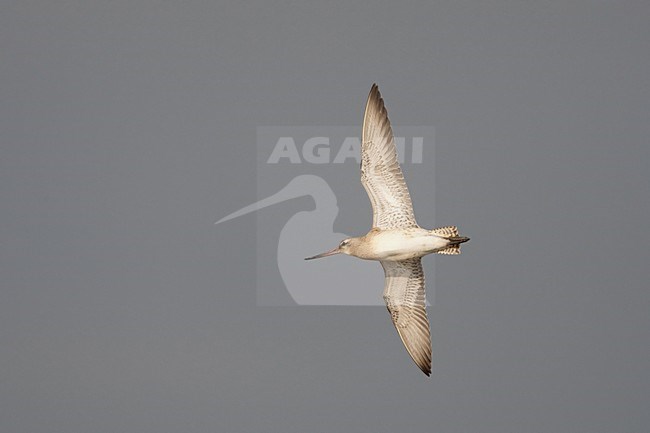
[{"x1": 305, "y1": 84, "x2": 469, "y2": 376}]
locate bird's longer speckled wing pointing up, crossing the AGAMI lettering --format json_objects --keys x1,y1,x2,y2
[{"x1": 361, "y1": 84, "x2": 418, "y2": 229}]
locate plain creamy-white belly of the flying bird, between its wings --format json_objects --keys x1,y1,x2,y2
[{"x1": 364, "y1": 230, "x2": 449, "y2": 261}]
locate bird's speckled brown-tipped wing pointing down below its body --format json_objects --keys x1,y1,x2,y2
[{"x1": 381, "y1": 258, "x2": 431, "y2": 376}]
